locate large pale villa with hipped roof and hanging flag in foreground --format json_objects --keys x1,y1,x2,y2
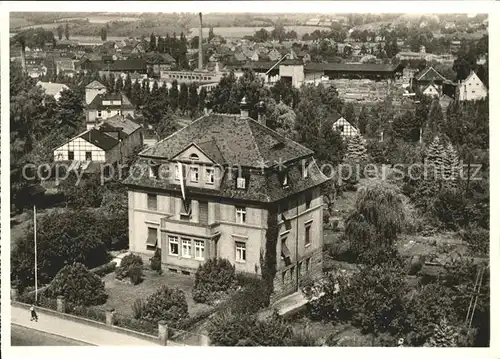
[{"x1": 124, "y1": 100, "x2": 326, "y2": 301}]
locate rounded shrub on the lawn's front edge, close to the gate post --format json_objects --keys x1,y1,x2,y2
[{"x1": 141, "y1": 286, "x2": 189, "y2": 327}]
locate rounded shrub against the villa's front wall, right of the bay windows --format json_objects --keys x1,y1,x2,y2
[{"x1": 193, "y1": 258, "x2": 236, "y2": 303}]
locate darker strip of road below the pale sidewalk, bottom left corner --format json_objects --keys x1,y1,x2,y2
[{"x1": 10, "y1": 324, "x2": 90, "y2": 346}]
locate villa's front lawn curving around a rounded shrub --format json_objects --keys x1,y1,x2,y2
[{"x1": 97, "y1": 268, "x2": 211, "y2": 317}]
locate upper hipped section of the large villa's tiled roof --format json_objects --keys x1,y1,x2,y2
[{"x1": 140, "y1": 114, "x2": 313, "y2": 168}]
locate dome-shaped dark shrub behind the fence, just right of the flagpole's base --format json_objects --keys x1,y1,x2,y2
[{"x1": 46, "y1": 263, "x2": 107, "y2": 306}]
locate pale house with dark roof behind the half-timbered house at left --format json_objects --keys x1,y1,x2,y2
[{"x1": 86, "y1": 93, "x2": 135, "y2": 128}]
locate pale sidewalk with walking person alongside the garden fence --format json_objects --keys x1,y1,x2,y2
[{"x1": 10, "y1": 306, "x2": 159, "y2": 346}]
